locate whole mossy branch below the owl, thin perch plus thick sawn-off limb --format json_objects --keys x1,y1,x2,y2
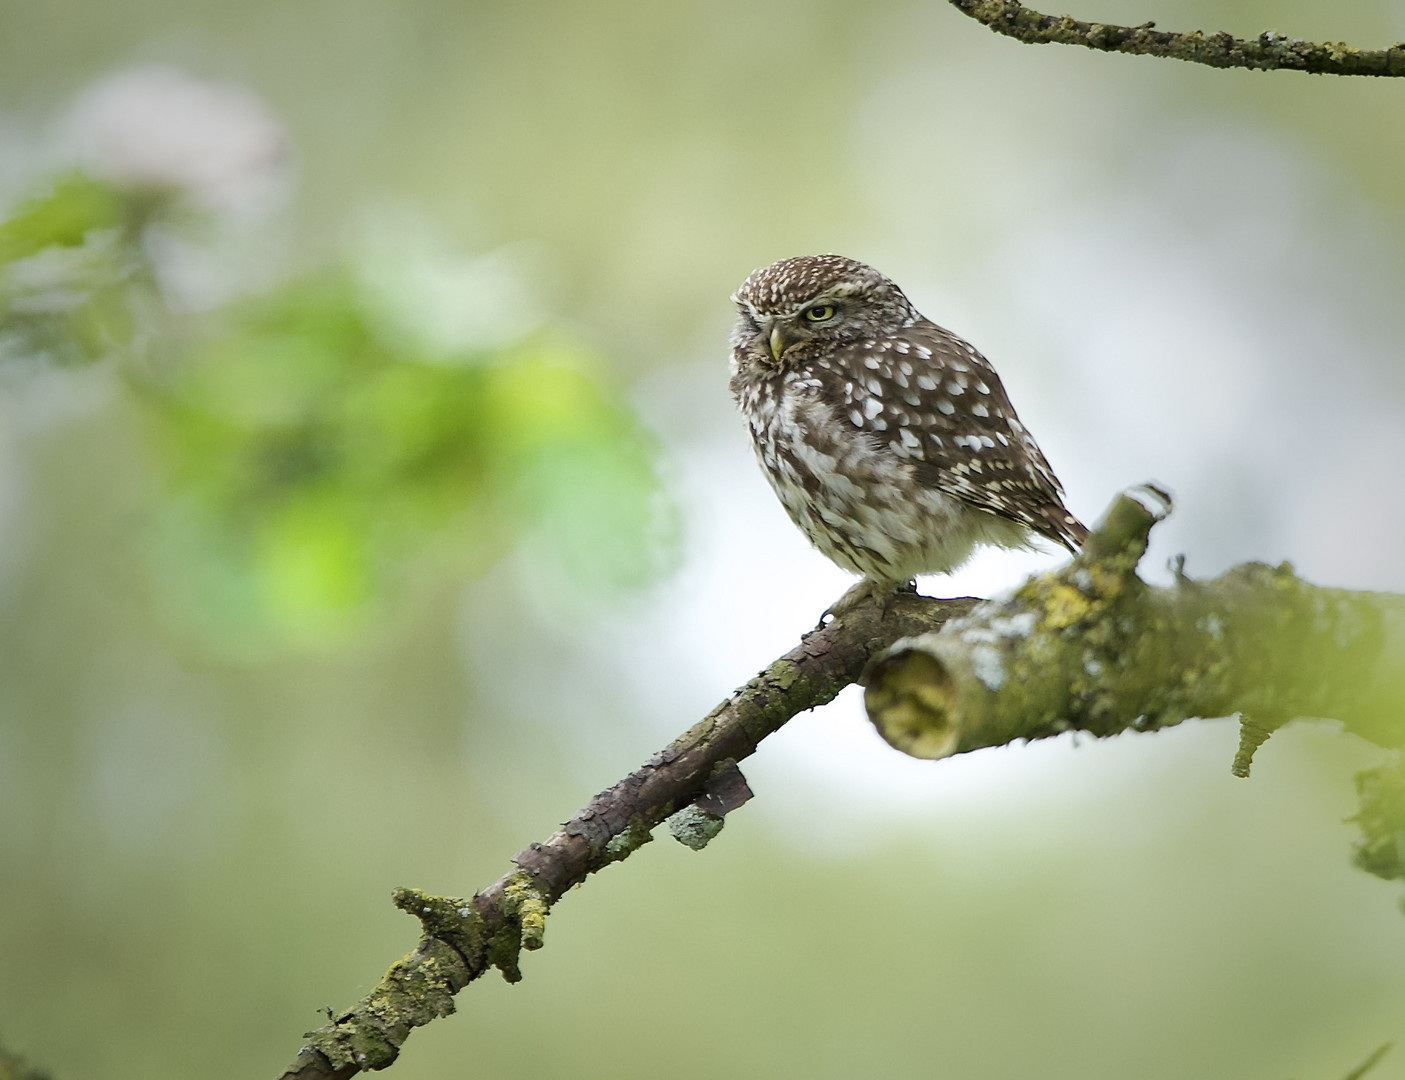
[{"x1": 273, "y1": 489, "x2": 1405, "y2": 1080}]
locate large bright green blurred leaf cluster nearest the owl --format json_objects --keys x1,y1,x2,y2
[{"x1": 150, "y1": 274, "x2": 666, "y2": 645}]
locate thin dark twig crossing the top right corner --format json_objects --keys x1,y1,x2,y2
[{"x1": 951, "y1": 0, "x2": 1405, "y2": 76}]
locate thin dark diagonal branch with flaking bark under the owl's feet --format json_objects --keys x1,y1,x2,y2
[{"x1": 273, "y1": 593, "x2": 976, "y2": 1080}]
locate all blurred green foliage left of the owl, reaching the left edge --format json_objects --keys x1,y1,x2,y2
[{"x1": 0, "y1": 176, "x2": 672, "y2": 654}]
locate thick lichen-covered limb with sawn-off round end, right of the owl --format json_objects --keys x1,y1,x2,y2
[{"x1": 864, "y1": 496, "x2": 1405, "y2": 764}]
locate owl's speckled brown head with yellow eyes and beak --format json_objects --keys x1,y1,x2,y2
[{"x1": 732, "y1": 256, "x2": 917, "y2": 368}]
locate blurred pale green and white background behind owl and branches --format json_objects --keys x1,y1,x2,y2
[{"x1": 0, "y1": 0, "x2": 1405, "y2": 1080}]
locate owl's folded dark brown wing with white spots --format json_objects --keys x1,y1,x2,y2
[{"x1": 825, "y1": 319, "x2": 1087, "y2": 551}]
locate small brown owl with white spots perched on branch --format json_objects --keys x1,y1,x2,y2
[{"x1": 731, "y1": 256, "x2": 1087, "y2": 598}]
